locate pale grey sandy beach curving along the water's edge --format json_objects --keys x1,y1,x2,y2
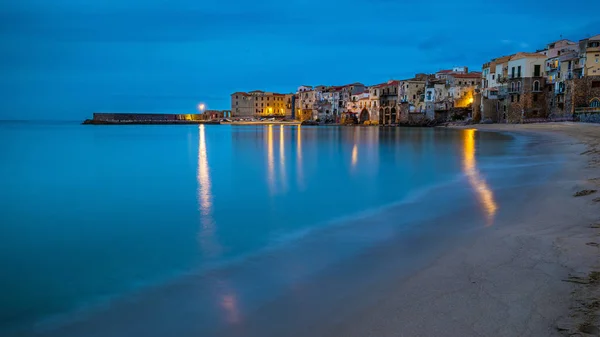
[{"x1": 323, "y1": 123, "x2": 600, "y2": 337}]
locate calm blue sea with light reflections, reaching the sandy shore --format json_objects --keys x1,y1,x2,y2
[{"x1": 0, "y1": 121, "x2": 562, "y2": 336}]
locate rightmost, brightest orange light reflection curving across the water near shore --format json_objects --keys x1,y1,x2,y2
[{"x1": 463, "y1": 129, "x2": 498, "y2": 226}]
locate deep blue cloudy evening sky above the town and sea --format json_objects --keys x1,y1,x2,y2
[{"x1": 0, "y1": 0, "x2": 600, "y2": 120}]
